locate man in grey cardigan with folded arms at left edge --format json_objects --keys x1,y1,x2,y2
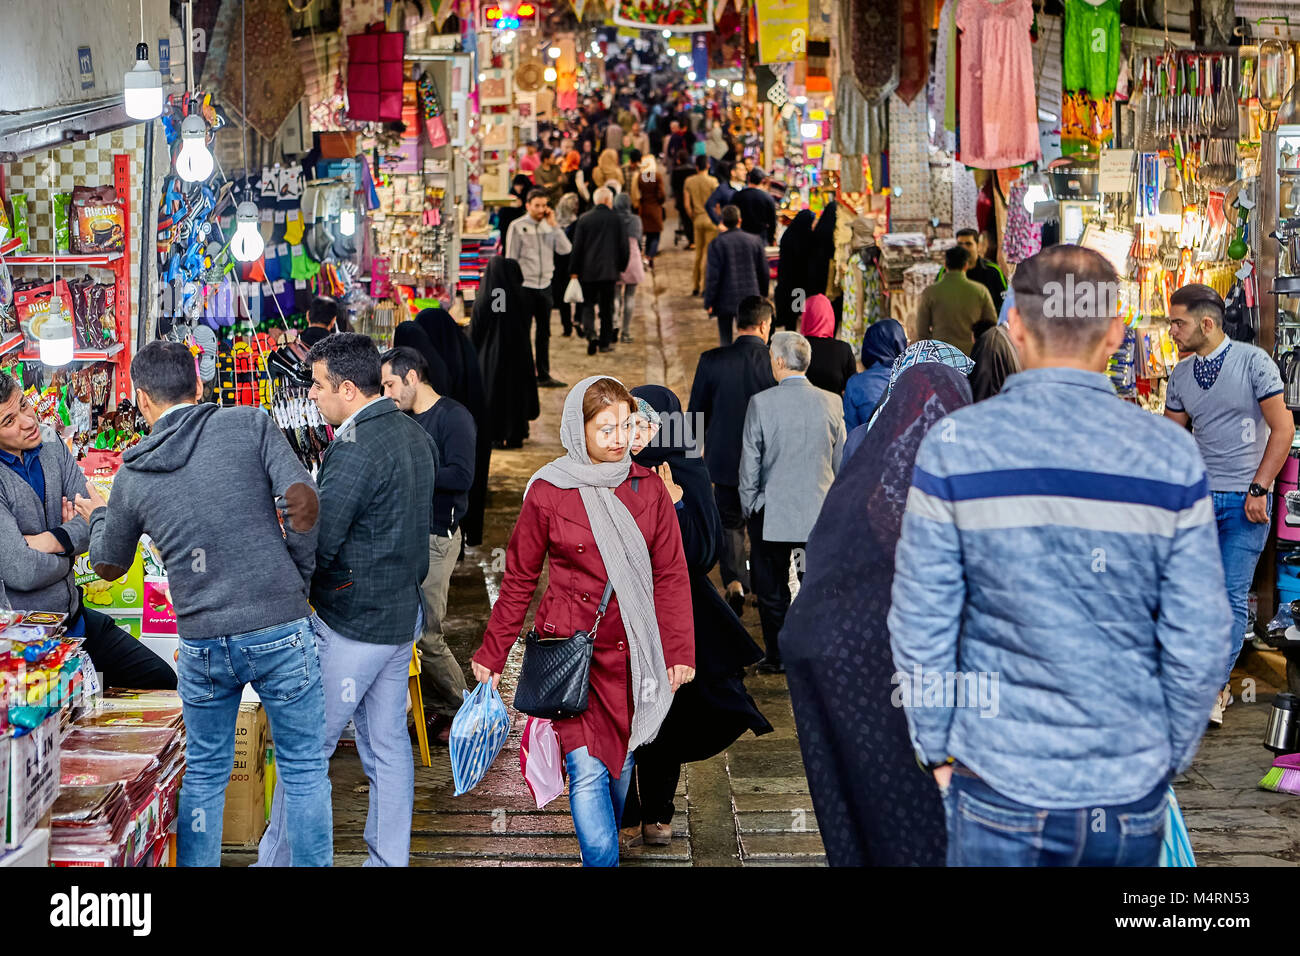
[{"x1": 0, "y1": 373, "x2": 176, "y2": 689}]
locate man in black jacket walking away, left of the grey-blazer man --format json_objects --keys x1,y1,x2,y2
[{"x1": 690, "y1": 295, "x2": 776, "y2": 615}]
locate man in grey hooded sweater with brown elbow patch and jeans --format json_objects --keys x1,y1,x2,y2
[{"x1": 83, "y1": 342, "x2": 333, "y2": 866}]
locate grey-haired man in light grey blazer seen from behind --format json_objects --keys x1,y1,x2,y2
[{"x1": 740, "y1": 332, "x2": 845, "y2": 674}]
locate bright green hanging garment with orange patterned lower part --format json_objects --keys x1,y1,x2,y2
[{"x1": 1061, "y1": 0, "x2": 1121, "y2": 152}]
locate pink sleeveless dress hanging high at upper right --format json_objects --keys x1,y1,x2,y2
[{"x1": 957, "y1": 0, "x2": 1041, "y2": 169}]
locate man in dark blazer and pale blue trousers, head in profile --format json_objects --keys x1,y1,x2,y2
[{"x1": 257, "y1": 332, "x2": 434, "y2": 866}]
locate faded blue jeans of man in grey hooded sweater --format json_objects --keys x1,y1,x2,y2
[{"x1": 177, "y1": 618, "x2": 334, "y2": 866}]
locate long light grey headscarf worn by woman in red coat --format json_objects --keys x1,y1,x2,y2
[{"x1": 524, "y1": 375, "x2": 672, "y2": 752}]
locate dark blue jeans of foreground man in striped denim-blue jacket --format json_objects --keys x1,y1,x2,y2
[{"x1": 944, "y1": 773, "x2": 1169, "y2": 866}]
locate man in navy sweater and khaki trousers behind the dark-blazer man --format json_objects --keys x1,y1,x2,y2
[{"x1": 380, "y1": 347, "x2": 476, "y2": 744}]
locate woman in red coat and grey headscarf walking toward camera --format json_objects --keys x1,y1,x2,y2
[{"x1": 472, "y1": 376, "x2": 696, "y2": 866}]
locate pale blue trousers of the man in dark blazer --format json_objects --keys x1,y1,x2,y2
[{"x1": 255, "y1": 614, "x2": 424, "y2": 866}]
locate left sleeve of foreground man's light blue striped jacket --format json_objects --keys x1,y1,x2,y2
[{"x1": 889, "y1": 429, "x2": 966, "y2": 763}]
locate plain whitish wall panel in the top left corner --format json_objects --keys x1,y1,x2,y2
[{"x1": 0, "y1": 0, "x2": 171, "y2": 111}]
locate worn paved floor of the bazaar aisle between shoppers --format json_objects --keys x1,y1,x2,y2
[{"x1": 202, "y1": 222, "x2": 1300, "y2": 866}]
